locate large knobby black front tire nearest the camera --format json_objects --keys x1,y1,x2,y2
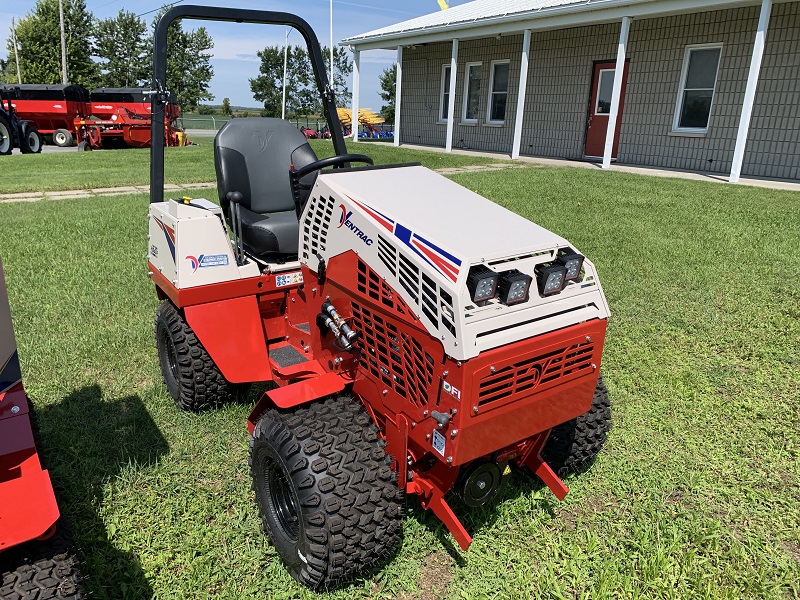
[{"x1": 249, "y1": 396, "x2": 403, "y2": 589}]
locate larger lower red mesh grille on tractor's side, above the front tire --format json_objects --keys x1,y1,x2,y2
[{"x1": 352, "y1": 302, "x2": 434, "y2": 406}]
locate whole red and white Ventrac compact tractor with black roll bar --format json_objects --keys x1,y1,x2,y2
[{"x1": 148, "y1": 6, "x2": 610, "y2": 588}]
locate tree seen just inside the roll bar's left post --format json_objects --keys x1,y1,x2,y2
[{"x1": 150, "y1": 7, "x2": 214, "y2": 112}]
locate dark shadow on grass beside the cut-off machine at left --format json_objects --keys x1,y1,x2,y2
[{"x1": 36, "y1": 385, "x2": 169, "y2": 600}]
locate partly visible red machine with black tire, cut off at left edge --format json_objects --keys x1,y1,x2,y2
[{"x1": 0, "y1": 261, "x2": 84, "y2": 600}]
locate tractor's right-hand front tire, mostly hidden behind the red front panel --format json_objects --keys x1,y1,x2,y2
[{"x1": 542, "y1": 376, "x2": 611, "y2": 477}]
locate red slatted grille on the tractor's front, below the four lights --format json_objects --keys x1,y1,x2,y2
[{"x1": 478, "y1": 342, "x2": 594, "y2": 405}]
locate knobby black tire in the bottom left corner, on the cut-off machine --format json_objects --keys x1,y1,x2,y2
[{"x1": 0, "y1": 523, "x2": 87, "y2": 600}]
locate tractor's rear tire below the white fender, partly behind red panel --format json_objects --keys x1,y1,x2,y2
[{"x1": 155, "y1": 300, "x2": 249, "y2": 412}]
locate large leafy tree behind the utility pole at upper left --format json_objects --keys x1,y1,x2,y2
[{"x1": 4, "y1": 0, "x2": 99, "y2": 88}]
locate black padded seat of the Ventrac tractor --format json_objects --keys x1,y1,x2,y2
[{"x1": 214, "y1": 117, "x2": 324, "y2": 259}]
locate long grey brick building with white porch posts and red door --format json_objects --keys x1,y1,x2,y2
[{"x1": 342, "y1": 0, "x2": 800, "y2": 182}]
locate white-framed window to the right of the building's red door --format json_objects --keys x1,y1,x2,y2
[{"x1": 673, "y1": 44, "x2": 722, "y2": 133}]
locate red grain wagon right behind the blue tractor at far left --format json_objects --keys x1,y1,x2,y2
[{"x1": 2, "y1": 84, "x2": 91, "y2": 146}]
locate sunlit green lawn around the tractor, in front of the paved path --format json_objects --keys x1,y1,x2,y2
[{"x1": 0, "y1": 157, "x2": 800, "y2": 600}]
